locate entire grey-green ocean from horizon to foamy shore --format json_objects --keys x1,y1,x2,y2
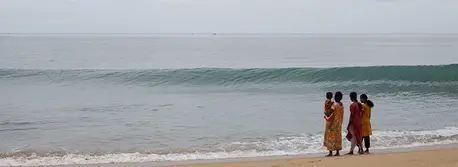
[{"x1": 0, "y1": 34, "x2": 458, "y2": 166}]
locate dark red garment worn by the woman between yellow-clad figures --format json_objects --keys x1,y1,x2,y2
[{"x1": 346, "y1": 102, "x2": 363, "y2": 146}]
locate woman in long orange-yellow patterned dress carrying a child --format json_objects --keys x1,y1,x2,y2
[{"x1": 323, "y1": 92, "x2": 344, "y2": 157}]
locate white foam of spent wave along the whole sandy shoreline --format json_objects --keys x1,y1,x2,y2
[{"x1": 0, "y1": 127, "x2": 458, "y2": 166}]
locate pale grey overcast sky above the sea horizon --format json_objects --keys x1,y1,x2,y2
[{"x1": 0, "y1": 0, "x2": 458, "y2": 33}]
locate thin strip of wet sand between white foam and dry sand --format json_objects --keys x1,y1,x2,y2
[{"x1": 49, "y1": 144, "x2": 458, "y2": 167}]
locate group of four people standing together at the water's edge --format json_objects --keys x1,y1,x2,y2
[{"x1": 323, "y1": 92, "x2": 374, "y2": 157}]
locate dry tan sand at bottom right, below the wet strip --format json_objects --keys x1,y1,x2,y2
[{"x1": 165, "y1": 149, "x2": 458, "y2": 167}]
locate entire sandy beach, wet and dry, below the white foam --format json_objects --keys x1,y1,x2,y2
[{"x1": 56, "y1": 144, "x2": 458, "y2": 167}]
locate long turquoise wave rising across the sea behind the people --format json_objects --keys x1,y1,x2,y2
[{"x1": 0, "y1": 64, "x2": 458, "y2": 86}]
